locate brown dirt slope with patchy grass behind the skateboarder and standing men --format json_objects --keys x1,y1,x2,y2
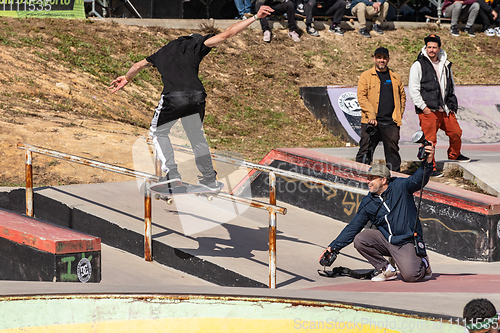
[{"x1": 0, "y1": 18, "x2": 500, "y2": 185}]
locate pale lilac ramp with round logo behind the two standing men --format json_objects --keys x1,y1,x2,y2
[{"x1": 300, "y1": 85, "x2": 500, "y2": 143}]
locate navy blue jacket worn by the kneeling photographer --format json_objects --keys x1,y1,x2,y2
[{"x1": 330, "y1": 162, "x2": 433, "y2": 251}]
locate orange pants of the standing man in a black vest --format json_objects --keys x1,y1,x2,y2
[{"x1": 418, "y1": 111, "x2": 462, "y2": 170}]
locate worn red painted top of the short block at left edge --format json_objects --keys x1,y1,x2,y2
[{"x1": 0, "y1": 210, "x2": 101, "y2": 254}]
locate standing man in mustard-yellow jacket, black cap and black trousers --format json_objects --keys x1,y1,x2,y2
[{"x1": 356, "y1": 47, "x2": 406, "y2": 172}]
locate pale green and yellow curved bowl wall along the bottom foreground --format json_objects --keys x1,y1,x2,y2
[{"x1": 0, "y1": 295, "x2": 464, "y2": 333}]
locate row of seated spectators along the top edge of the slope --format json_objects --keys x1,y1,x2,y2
[{"x1": 234, "y1": 0, "x2": 500, "y2": 42}]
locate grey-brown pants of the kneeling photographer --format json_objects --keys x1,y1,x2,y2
[{"x1": 354, "y1": 229, "x2": 425, "y2": 282}]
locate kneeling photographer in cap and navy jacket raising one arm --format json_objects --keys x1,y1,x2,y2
[{"x1": 320, "y1": 144, "x2": 434, "y2": 282}]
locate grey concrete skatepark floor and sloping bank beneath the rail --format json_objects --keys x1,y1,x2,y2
[{"x1": 0, "y1": 165, "x2": 500, "y2": 317}]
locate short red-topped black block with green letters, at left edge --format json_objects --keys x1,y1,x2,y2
[{"x1": 0, "y1": 210, "x2": 101, "y2": 282}]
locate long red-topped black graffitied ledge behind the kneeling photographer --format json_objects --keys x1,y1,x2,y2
[{"x1": 233, "y1": 148, "x2": 500, "y2": 261}]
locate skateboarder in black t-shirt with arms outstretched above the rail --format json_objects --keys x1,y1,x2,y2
[{"x1": 109, "y1": 6, "x2": 273, "y2": 191}]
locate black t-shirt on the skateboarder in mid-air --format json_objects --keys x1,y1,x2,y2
[{"x1": 146, "y1": 34, "x2": 214, "y2": 94}]
